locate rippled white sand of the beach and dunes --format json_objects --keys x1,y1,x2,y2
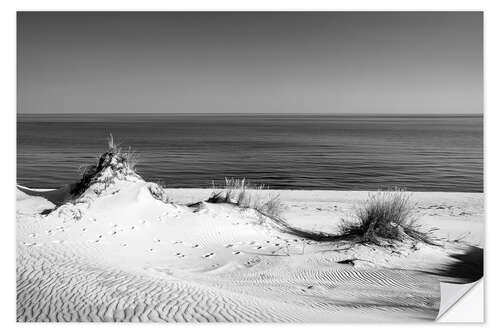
[{"x1": 17, "y1": 176, "x2": 484, "y2": 322}]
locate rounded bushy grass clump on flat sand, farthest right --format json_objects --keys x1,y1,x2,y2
[{"x1": 341, "y1": 188, "x2": 434, "y2": 245}]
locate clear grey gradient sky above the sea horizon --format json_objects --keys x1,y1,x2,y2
[{"x1": 17, "y1": 12, "x2": 483, "y2": 114}]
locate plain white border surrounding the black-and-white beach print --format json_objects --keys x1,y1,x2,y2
[{"x1": 0, "y1": 0, "x2": 500, "y2": 333}]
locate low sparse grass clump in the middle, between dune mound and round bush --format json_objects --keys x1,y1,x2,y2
[{"x1": 207, "y1": 178, "x2": 284, "y2": 219}]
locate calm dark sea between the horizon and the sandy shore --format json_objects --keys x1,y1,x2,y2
[{"x1": 17, "y1": 115, "x2": 483, "y2": 192}]
